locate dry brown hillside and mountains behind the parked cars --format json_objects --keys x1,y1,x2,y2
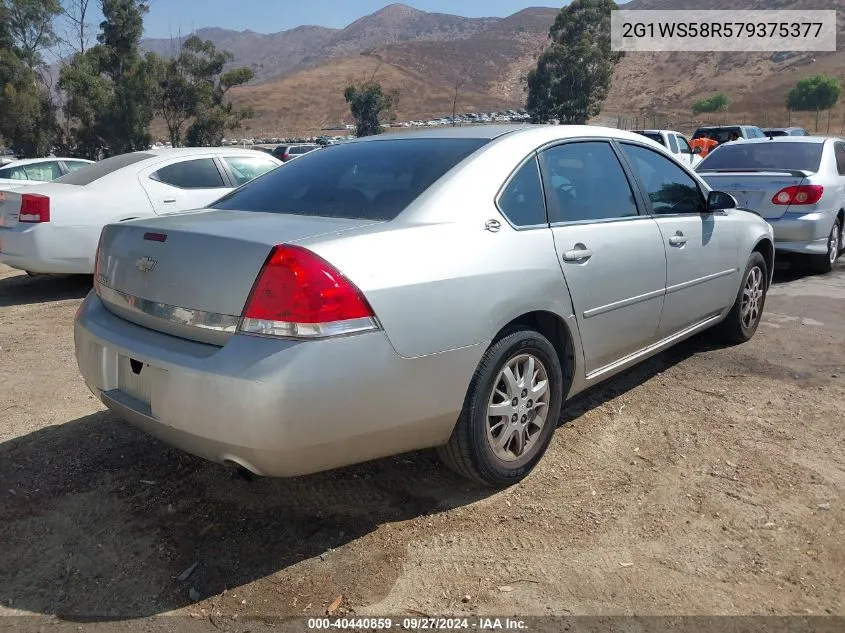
[{"x1": 144, "y1": 0, "x2": 845, "y2": 136}]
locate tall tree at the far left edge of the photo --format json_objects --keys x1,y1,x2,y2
[{"x1": 0, "y1": 0, "x2": 60, "y2": 156}]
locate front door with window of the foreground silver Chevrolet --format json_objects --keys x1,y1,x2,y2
[{"x1": 620, "y1": 142, "x2": 739, "y2": 339}]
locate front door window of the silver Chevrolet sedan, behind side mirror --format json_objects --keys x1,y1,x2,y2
[{"x1": 622, "y1": 143, "x2": 704, "y2": 214}]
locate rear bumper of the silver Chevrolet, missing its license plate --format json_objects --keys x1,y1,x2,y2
[{"x1": 74, "y1": 293, "x2": 485, "y2": 476}]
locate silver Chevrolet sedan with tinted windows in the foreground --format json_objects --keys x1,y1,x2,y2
[{"x1": 75, "y1": 126, "x2": 774, "y2": 485}]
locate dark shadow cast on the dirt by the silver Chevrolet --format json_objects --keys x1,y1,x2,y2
[{"x1": 0, "y1": 337, "x2": 724, "y2": 622}]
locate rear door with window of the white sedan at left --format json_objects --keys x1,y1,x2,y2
[{"x1": 139, "y1": 155, "x2": 232, "y2": 214}]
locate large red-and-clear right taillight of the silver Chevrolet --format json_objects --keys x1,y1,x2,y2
[{"x1": 239, "y1": 244, "x2": 378, "y2": 338}]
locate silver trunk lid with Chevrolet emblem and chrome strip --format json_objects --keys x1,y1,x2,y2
[{"x1": 95, "y1": 210, "x2": 375, "y2": 345}]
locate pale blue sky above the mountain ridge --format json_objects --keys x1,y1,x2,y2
[{"x1": 130, "y1": 0, "x2": 565, "y2": 37}]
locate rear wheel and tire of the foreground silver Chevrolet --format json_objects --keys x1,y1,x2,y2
[{"x1": 438, "y1": 329, "x2": 563, "y2": 487}]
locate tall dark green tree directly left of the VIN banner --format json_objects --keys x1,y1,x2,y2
[{"x1": 526, "y1": 0, "x2": 623, "y2": 124}]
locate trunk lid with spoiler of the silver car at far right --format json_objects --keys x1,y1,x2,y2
[{"x1": 698, "y1": 169, "x2": 813, "y2": 220}]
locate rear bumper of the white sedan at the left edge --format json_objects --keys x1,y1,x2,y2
[{"x1": 0, "y1": 224, "x2": 99, "y2": 275}]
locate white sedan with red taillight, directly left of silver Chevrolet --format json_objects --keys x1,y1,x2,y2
[{"x1": 0, "y1": 147, "x2": 282, "y2": 274}]
